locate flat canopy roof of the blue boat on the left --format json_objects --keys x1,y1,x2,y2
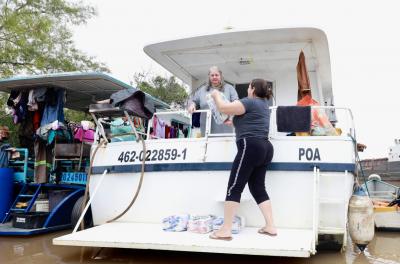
[{"x1": 0, "y1": 72, "x2": 169, "y2": 111}]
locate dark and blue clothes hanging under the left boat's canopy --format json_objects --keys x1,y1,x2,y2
[{"x1": 7, "y1": 87, "x2": 68, "y2": 183}]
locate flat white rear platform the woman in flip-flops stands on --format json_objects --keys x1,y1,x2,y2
[{"x1": 53, "y1": 222, "x2": 313, "y2": 257}]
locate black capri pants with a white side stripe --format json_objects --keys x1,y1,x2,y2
[{"x1": 225, "y1": 137, "x2": 274, "y2": 204}]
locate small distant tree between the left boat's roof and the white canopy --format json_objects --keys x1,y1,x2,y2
[{"x1": 134, "y1": 73, "x2": 188, "y2": 108}]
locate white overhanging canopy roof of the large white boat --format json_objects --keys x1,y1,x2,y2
[{"x1": 144, "y1": 28, "x2": 332, "y2": 96}]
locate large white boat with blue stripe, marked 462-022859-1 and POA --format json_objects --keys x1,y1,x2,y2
[{"x1": 49, "y1": 28, "x2": 356, "y2": 257}]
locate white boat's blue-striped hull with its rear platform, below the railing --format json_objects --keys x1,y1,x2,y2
[{"x1": 54, "y1": 137, "x2": 355, "y2": 257}]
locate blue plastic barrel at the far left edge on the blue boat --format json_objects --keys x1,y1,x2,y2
[{"x1": 0, "y1": 168, "x2": 14, "y2": 223}]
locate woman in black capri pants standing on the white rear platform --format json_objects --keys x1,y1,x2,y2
[{"x1": 210, "y1": 79, "x2": 277, "y2": 240}]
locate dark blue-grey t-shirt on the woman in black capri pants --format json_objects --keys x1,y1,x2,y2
[{"x1": 233, "y1": 97, "x2": 270, "y2": 140}]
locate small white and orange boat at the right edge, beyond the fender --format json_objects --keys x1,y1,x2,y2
[{"x1": 363, "y1": 174, "x2": 400, "y2": 230}]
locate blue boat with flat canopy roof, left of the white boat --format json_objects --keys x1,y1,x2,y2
[{"x1": 0, "y1": 72, "x2": 168, "y2": 236}]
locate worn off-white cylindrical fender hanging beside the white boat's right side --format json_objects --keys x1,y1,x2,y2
[{"x1": 349, "y1": 187, "x2": 375, "y2": 251}]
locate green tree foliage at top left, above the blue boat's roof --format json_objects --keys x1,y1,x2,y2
[{"x1": 0, "y1": 0, "x2": 108, "y2": 78}]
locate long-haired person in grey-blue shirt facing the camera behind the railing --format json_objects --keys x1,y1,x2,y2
[{"x1": 188, "y1": 66, "x2": 239, "y2": 135}]
